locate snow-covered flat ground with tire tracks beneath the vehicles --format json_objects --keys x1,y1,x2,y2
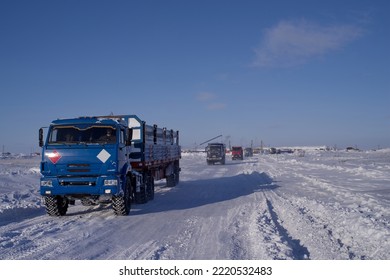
[{"x1": 0, "y1": 149, "x2": 390, "y2": 260}]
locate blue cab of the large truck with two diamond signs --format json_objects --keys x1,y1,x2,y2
[{"x1": 39, "y1": 117, "x2": 136, "y2": 216}]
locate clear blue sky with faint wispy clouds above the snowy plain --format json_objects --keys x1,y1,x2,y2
[{"x1": 0, "y1": 0, "x2": 390, "y2": 152}]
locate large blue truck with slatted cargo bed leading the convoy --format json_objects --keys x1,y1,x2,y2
[{"x1": 39, "y1": 115, "x2": 181, "y2": 216}]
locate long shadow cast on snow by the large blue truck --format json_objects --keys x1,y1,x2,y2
[{"x1": 130, "y1": 172, "x2": 279, "y2": 216}]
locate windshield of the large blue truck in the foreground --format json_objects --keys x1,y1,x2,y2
[{"x1": 48, "y1": 125, "x2": 116, "y2": 144}]
